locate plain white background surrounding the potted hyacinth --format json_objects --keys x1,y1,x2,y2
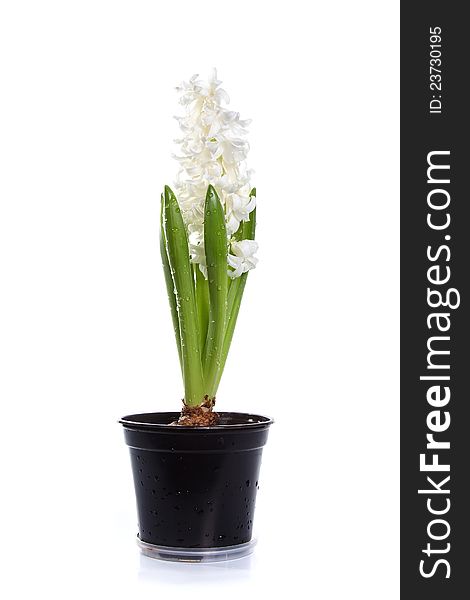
[{"x1": 0, "y1": 0, "x2": 399, "y2": 600}]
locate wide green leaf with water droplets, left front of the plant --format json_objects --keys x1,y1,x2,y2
[{"x1": 163, "y1": 186, "x2": 204, "y2": 406}]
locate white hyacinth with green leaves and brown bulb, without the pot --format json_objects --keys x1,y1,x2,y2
[{"x1": 160, "y1": 70, "x2": 258, "y2": 425}]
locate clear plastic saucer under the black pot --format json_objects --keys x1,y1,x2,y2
[{"x1": 137, "y1": 535, "x2": 256, "y2": 563}]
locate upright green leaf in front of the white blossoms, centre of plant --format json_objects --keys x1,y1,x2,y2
[{"x1": 203, "y1": 185, "x2": 228, "y2": 398}]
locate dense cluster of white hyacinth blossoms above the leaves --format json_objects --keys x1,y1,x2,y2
[{"x1": 175, "y1": 69, "x2": 258, "y2": 278}]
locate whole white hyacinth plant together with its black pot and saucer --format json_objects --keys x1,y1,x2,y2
[{"x1": 120, "y1": 71, "x2": 272, "y2": 561}]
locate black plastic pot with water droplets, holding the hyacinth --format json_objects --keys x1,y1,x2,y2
[{"x1": 120, "y1": 412, "x2": 272, "y2": 549}]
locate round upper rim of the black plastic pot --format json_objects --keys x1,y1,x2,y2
[{"x1": 119, "y1": 411, "x2": 274, "y2": 434}]
